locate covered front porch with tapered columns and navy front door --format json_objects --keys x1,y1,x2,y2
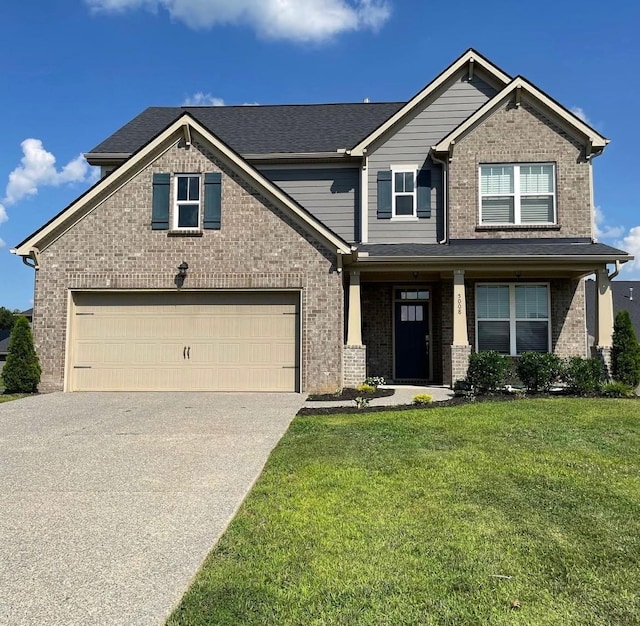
[{"x1": 343, "y1": 240, "x2": 627, "y2": 386}]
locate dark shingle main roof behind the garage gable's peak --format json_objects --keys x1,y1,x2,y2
[{"x1": 90, "y1": 102, "x2": 404, "y2": 154}]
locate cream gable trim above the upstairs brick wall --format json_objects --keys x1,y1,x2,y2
[{"x1": 431, "y1": 76, "x2": 609, "y2": 155}]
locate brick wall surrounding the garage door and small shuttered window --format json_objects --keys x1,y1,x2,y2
[{"x1": 33, "y1": 143, "x2": 344, "y2": 392}]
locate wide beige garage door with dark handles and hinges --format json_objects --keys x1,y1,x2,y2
[{"x1": 68, "y1": 292, "x2": 299, "y2": 391}]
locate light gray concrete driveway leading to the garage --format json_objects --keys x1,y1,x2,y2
[{"x1": 0, "y1": 393, "x2": 304, "y2": 626}]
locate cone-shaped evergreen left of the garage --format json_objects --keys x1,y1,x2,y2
[{"x1": 2, "y1": 317, "x2": 42, "y2": 393}]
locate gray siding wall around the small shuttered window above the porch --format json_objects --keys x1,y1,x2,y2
[{"x1": 368, "y1": 70, "x2": 497, "y2": 243}]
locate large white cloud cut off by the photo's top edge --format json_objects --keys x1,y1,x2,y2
[{"x1": 85, "y1": 0, "x2": 391, "y2": 42}]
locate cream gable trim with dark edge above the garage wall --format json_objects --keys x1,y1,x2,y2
[{"x1": 11, "y1": 113, "x2": 350, "y2": 256}]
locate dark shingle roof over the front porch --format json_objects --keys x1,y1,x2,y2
[{"x1": 358, "y1": 238, "x2": 627, "y2": 259}]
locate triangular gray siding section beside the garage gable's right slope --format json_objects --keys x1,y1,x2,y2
[{"x1": 260, "y1": 166, "x2": 360, "y2": 243}]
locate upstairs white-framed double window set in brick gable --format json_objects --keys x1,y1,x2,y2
[{"x1": 480, "y1": 163, "x2": 556, "y2": 224}]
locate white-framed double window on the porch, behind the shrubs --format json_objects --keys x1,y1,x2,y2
[{"x1": 476, "y1": 284, "x2": 550, "y2": 356}]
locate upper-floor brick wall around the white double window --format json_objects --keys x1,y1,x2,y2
[{"x1": 449, "y1": 100, "x2": 592, "y2": 239}]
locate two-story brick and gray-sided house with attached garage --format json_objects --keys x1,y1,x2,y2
[{"x1": 13, "y1": 50, "x2": 632, "y2": 391}]
